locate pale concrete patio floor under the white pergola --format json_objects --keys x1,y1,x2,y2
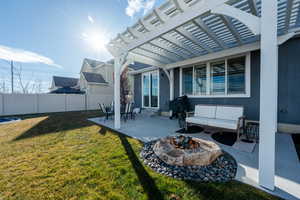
[{"x1": 90, "y1": 114, "x2": 300, "y2": 200}]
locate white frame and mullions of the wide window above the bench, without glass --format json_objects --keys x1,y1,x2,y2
[{"x1": 179, "y1": 52, "x2": 251, "y2": 98}]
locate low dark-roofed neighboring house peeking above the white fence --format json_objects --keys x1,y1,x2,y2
[{"x1": 49, "y1": 76, "x2": 83, "y2": 94}]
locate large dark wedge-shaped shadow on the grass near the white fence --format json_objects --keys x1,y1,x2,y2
[{"x1": 13, "y1": 111, "x2": 101, "y2": 141}]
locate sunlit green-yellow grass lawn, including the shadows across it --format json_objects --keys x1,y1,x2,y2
[{"x1": 0, "y1": 112, "x2": 277, "y2": 200}]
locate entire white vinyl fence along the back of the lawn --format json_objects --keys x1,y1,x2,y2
[{"x1": 0, "y1": 94, "x2": 113, "y2": 116}]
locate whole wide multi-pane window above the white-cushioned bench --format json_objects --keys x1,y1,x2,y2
[{"x1": 181, "y1": 54, "x2": 250, "y2": 97}]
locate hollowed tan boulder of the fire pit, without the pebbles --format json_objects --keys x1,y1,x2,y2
[{"x1": 153, "y1": 136, "x2": 223, "y2": 166}]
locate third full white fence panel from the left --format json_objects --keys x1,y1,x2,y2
[{"x1": 66, "y1": 94, "x2": 86, "y2": 111}]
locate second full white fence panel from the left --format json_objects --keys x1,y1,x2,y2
[{"x1": 38, "y1": 94, "x2": 66, "y2": 113}]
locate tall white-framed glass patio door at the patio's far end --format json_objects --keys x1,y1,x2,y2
[{"x1": 142, "y1": 71, "x2": 159, "y2": 108}]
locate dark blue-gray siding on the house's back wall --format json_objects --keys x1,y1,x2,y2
[{"x1": 135, "y1": 38, "x2": 300, "y2": 124}]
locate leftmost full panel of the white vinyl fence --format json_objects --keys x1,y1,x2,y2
[{"x1": 2, "y1": 94, "x2": 37, "y2": 115}]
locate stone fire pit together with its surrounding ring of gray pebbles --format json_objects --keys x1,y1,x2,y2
[{"x1": 140, "y1": 136, "x2": 237, "y2": 182}]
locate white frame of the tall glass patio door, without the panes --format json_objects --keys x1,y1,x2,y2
[{"x1": 141, "y1": 70, "x2": 160, "y2": 109}]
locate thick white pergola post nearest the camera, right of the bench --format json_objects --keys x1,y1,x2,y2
[{"x1": 259, "y1": 0, "x2": 278, "y2": 190}]
